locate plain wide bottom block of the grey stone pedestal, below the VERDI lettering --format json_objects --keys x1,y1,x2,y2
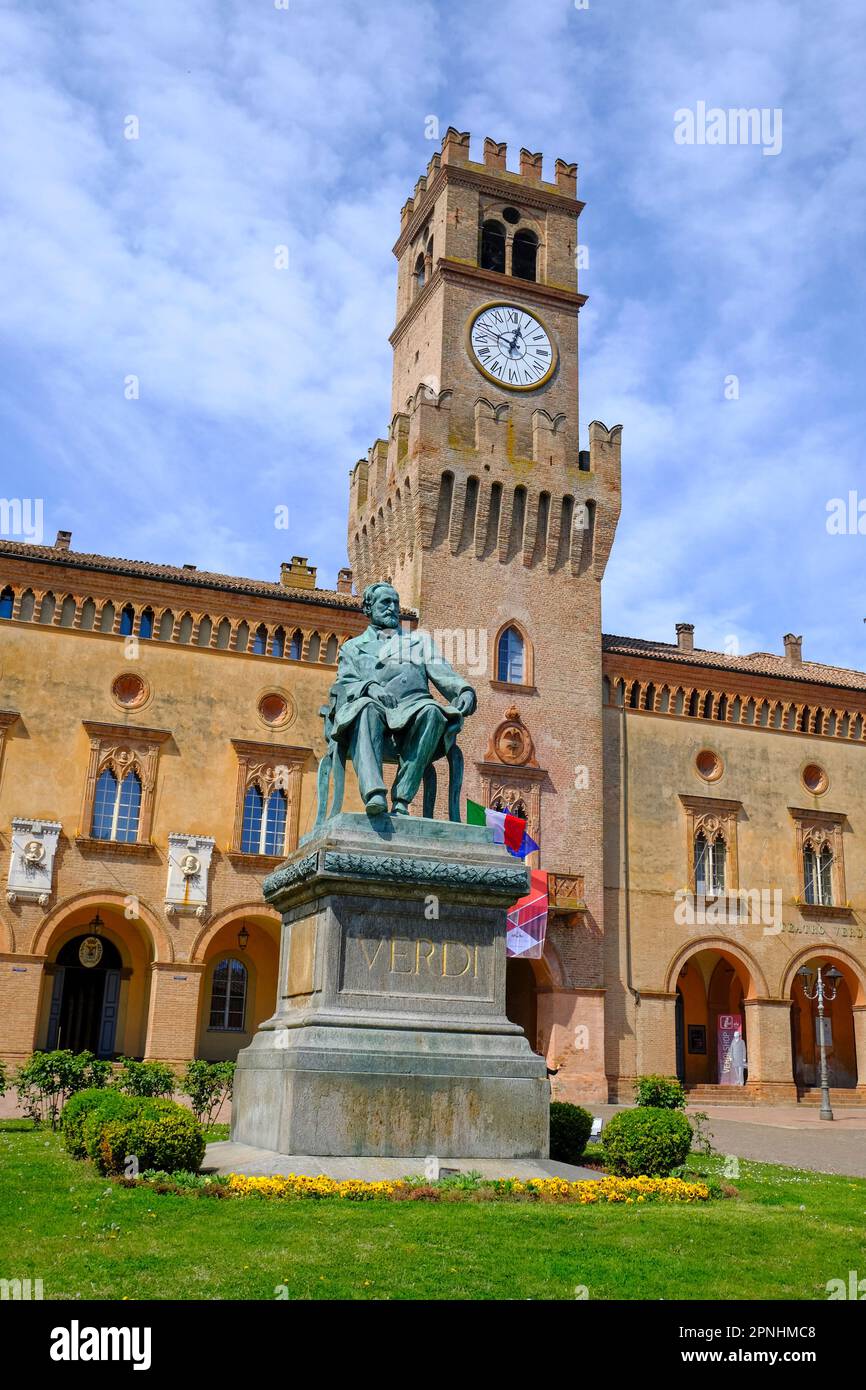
[{"x1": 232, "y1": 1026, "x2": 550, "y2": 1158}]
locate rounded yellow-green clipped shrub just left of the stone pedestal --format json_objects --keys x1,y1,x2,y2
[{"x1": 94, "y1": 1097, "x2": 204, "y2": 1173}]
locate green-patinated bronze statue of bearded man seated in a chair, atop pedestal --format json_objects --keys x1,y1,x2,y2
[{"x1": 317, "y1": 582, "x2": 477, "y2": 821}]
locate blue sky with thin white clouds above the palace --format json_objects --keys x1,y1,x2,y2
[{"x1": 0, "y1": 0, "x2": 866, "y2": 667}]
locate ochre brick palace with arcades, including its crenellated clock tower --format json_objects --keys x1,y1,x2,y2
[{"x1": 0, "y1": 129, "x2": 866, "y2": 1101}]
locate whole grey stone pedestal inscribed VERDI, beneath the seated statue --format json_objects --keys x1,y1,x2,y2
[{"x1": 232, "y1": 813, "x2": 549, "y2": 1158}]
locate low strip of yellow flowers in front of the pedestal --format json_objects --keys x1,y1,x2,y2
[{"x1": 228, "y1": 1173, "x2": 710, "y2": 1207}]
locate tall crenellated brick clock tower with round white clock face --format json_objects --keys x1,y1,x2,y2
[{"x1": 349, "y1": 128, "x2": 621, "y2": 1101}]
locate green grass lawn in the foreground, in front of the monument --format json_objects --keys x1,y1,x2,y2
[{"x1": 0, "y1": 1120, "x2": 866, "y2": 1298}]
